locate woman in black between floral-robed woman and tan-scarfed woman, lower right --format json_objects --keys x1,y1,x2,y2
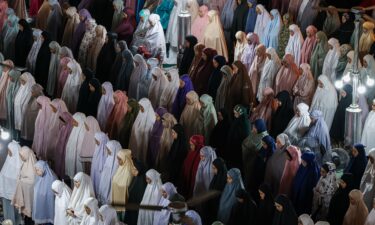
[{"x1": 327, "y1": 173, "x2": 353, "y2": 225}]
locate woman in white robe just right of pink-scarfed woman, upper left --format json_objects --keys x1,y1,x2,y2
[{"x1": 61, "y1": 60, "x2": 82, "y2": 113}]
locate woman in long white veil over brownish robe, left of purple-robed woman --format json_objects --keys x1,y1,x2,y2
[{"x1": 129, "y1": 98, "x2": 156, "y2": 163}]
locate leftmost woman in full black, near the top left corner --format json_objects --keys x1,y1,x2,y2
[{"x1": 14, "y1": 19, "x2": 34, "y2": 67}]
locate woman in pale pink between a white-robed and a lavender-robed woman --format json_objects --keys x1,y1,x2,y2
[{"x1": 80, "y1": 116, "x2": 100, "y2": 162}]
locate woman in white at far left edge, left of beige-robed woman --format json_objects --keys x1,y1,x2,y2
[{"x1": 0, "y1": 141, "x2": 22, "y2": 200}]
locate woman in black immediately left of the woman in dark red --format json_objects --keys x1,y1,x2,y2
[{"x1": 167, "y1": 124, "x2": 188, "y2": 184}]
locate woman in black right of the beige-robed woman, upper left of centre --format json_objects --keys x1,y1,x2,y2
[{"x1": 96, "y1": 33, "x2": 117, "y2": 83}]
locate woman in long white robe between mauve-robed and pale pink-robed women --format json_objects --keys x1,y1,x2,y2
[{"x1": 65, "y1": 112, "x2": 86, "y2": 177}]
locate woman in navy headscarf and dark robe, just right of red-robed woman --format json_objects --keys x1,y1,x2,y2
[{"x1": 291, "y1": 151, "x2": 319, "y2": 215}]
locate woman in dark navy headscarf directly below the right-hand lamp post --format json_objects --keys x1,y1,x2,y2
[{"x1": 345, "y1": 144, "x2": 367, "y2": 189}]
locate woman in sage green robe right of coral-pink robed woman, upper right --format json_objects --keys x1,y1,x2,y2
[{"x1": 310, "y1": 31, "x2": 328, "y2": 79}]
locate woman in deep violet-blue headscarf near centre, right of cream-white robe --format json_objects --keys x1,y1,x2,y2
[{"x1": 172, "y1": 74, "x2": 194, "y2": 121}]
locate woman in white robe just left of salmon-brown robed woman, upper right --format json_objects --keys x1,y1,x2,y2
[{"x1": 257, "y1": 48, "x2": 281, "y2": 102}]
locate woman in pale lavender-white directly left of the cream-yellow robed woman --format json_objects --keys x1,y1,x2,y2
[{"x1": 97, "y1": 140, "x2": 122, "y2": 204}]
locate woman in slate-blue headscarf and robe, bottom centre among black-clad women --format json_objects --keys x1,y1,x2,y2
[{"x1": 218, "y1": 168, "x2": 244, "y2": 224}]
